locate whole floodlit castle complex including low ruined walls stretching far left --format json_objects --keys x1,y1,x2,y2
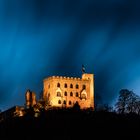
[{"x1": 0, "y1": 73, "x2": 94, "y2": 121}]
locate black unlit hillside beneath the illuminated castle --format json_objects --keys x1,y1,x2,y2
[{"x1": 0, "y1": 110, "x2": 140, "y2": 140}]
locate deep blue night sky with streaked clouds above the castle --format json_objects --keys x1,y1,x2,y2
[{"x1": 0, "y1": 0, "x2": 140, "y2": 110}]
